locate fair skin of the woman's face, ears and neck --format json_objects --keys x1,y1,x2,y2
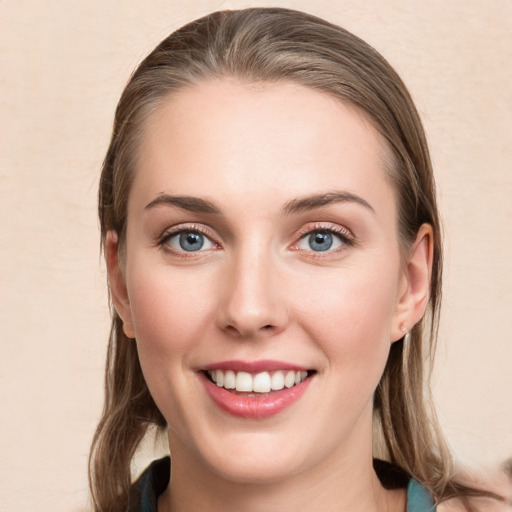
[{"x1": 106, "y1": 79, "x2": 432, "y2": 512}]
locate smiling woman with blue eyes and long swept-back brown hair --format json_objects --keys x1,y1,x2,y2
[{"x1": 91, "y1": 9, "x2": 506, "y2": 512}]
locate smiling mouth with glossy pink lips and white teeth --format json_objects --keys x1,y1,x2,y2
[{"x1": 199, "y1": 361, "x2": 316, "y2": 419}]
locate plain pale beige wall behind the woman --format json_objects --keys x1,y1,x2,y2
[{"x1": 0, "y1": 0, "x2": 512, "y2": 512}]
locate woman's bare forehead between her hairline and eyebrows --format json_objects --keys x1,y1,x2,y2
[{"x1": 133, "y1": 79, "x2": 394, "y2": 216}]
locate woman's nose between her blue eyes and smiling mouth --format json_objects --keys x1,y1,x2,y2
[{"x1": 218, "y1": 245, "x2": 289, "y2": 339}]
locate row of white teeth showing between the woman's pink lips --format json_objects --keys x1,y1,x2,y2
[{"x1": 208, "y1": 370, "x2": 308, "y2": 393}]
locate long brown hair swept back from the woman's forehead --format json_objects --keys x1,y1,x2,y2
[{"x1": 90, "y1": 8, "x2": 502, "y2": 512}]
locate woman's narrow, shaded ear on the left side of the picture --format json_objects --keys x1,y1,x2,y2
[{"x1": 105, "y1": 231, "x2": 135, "y2": 338}]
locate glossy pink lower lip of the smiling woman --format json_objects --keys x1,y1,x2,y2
[{"x1": 200, "y1": 372, "x2": 312, "y2": 419}]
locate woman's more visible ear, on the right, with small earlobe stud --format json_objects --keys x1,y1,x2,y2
[{"x1": 391, "y1": 224, "x2": 434, "y2": 341}]
